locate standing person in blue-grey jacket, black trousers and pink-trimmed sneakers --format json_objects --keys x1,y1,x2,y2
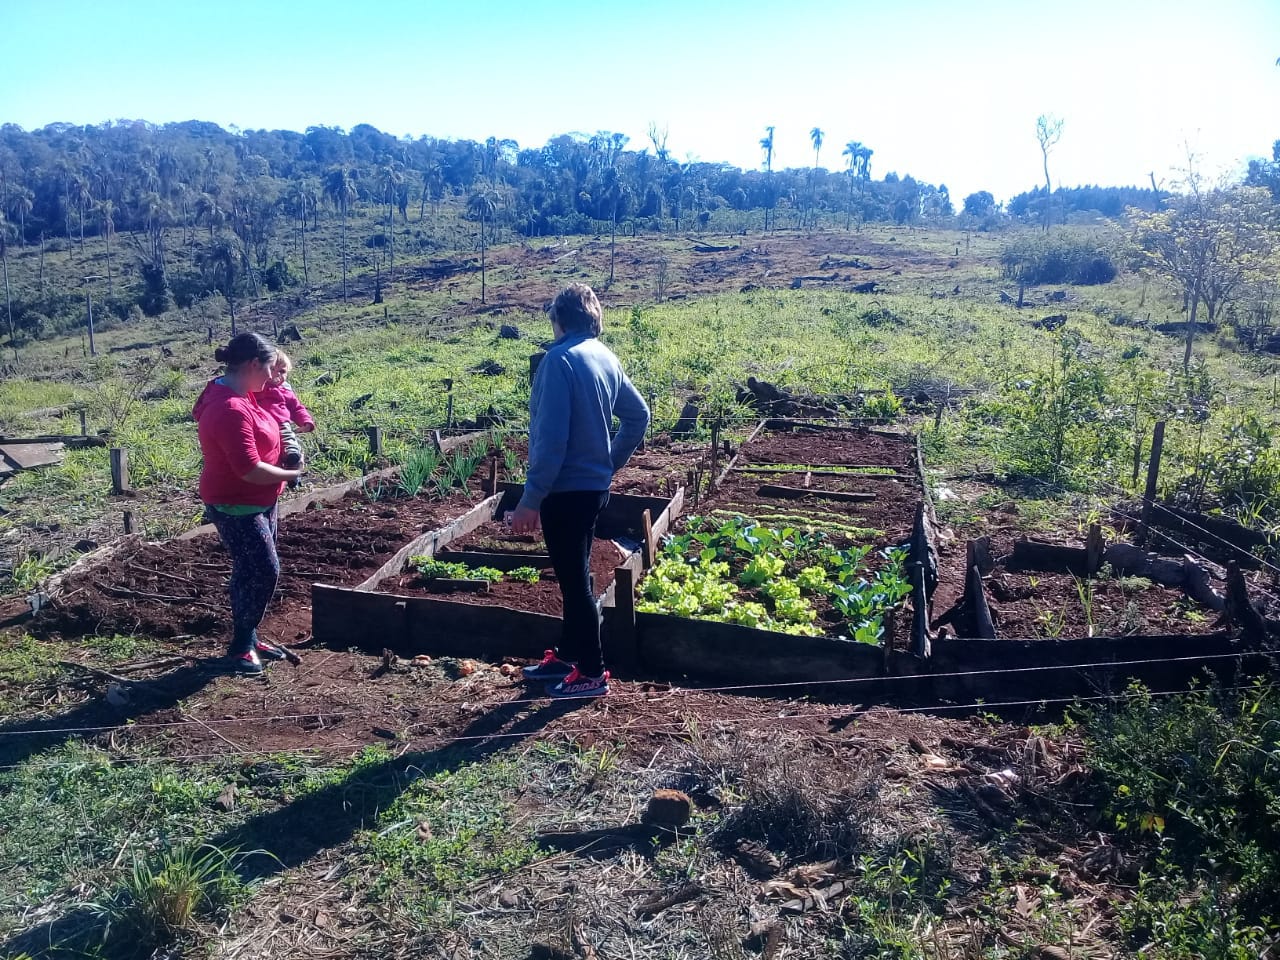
[{"x1": 509, "y1": 283, "x2": 649, "y2": 698}]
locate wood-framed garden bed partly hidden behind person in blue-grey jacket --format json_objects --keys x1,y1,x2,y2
[{"x1": 311, "y1": 484, "x2": 684, "y2": 657}]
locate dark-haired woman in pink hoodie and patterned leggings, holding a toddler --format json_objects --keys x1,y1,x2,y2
[{"x1": 192, "y1": 333, "x2": 302, "y2": 675}]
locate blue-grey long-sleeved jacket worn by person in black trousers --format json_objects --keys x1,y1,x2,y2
[{"x1": 520, "y1": 333, "x2": 649, "y2": 509}]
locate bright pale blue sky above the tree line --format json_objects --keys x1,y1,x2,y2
[{"x1": 0, "y1": 0, "x2": 1280, "y2": 198}]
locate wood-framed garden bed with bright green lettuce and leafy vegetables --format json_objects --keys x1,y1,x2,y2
[{"x1": 622, "y1": 424, "x2": 927, "y2": 682}]
